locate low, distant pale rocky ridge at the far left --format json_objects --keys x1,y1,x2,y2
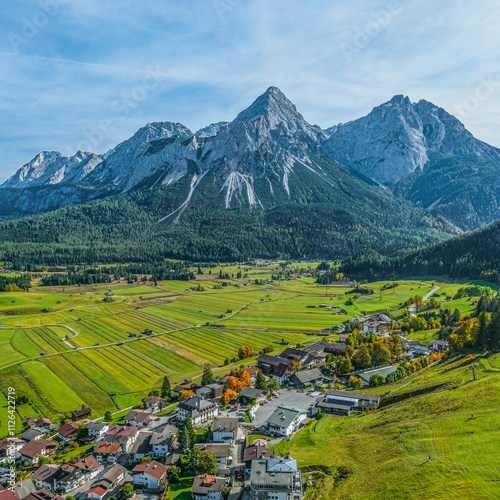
[{"x1": 2, "y1": 151, "x2": 103, "y2": 188}]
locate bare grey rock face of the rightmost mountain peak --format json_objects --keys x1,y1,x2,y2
[{"x1": 323, "y1": 95, "x2": 500, "y2": 184}]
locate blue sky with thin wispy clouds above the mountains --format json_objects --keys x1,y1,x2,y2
[{"x1": 0, "y1": 0, "x2": 500, "y2": 181}]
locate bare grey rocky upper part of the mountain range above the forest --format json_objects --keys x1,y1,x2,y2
[{"x1": 0, "y1": 87, "x2": 500, "y2": 222}]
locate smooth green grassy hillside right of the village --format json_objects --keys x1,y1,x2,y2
[{"x1": 275, "y1": 355, "x2": 500, "y2": 500}]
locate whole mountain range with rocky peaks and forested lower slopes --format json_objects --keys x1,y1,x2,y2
[{"x1": 0, "y1": 87, "x2": 500, "y2": 264}]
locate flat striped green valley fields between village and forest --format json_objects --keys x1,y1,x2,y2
[{"x1": 0, "y1": 272, "x2": 498, "y2": 436}]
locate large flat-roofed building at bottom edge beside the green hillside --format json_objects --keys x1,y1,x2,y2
[{"x1": 250, "y1": 457, "x2": 304, "y2": 500}]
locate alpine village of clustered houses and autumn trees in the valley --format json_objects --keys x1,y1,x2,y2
[{"x1": 0, "y1": 305, "x2": 448, "y2": 500}]
